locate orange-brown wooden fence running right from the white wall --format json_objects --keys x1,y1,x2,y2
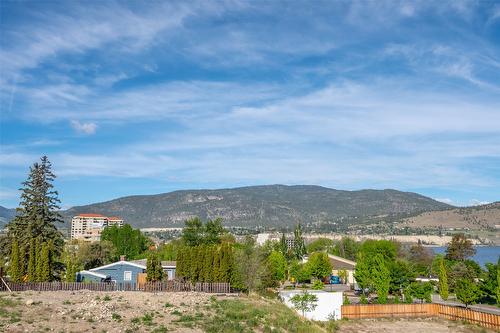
[{"x1": 342, "y1": 303, "x2": 500, "y2": 330}]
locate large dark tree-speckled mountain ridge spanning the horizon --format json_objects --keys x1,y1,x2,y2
[{"x1": 63, "y1": 185, "x2": 452, "y2": 227}]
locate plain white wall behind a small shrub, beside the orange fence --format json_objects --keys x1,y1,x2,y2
[{"x1": 280, "y1": 290, "x2": 344, "y2": 321}]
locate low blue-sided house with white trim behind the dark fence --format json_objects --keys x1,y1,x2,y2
[{"x1": 76, "y1": 259, "x2": 176, "y2": 283}]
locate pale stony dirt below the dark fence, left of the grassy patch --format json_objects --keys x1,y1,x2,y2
[{"x1": 0, "y1": 291, "x2": 210, "y2": 332}]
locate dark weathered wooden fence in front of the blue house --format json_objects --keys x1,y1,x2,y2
[{"x1": 0, "y1": 281, "x2": 231, "y2": 293}]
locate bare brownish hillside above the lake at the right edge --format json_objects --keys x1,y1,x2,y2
[{"x1": 402, "y1": 201, "x2": 500, "y2": 230}]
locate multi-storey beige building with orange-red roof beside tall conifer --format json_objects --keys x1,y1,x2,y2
[{"x1": 71, "y1": 214, "x2": 123, "y2": 242}]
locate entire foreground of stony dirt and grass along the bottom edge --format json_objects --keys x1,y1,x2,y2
[{"x1": 0, "y1": 291, "x2": 496, "y2": 333}]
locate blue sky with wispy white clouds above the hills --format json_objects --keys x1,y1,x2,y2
[{"x1": 0, "y1": 0, "x2": 500, "y2": 207}]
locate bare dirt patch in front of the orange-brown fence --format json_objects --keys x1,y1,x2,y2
[{"x1": 338, "y1": 318, "x2": 492, "y2": 333}]
